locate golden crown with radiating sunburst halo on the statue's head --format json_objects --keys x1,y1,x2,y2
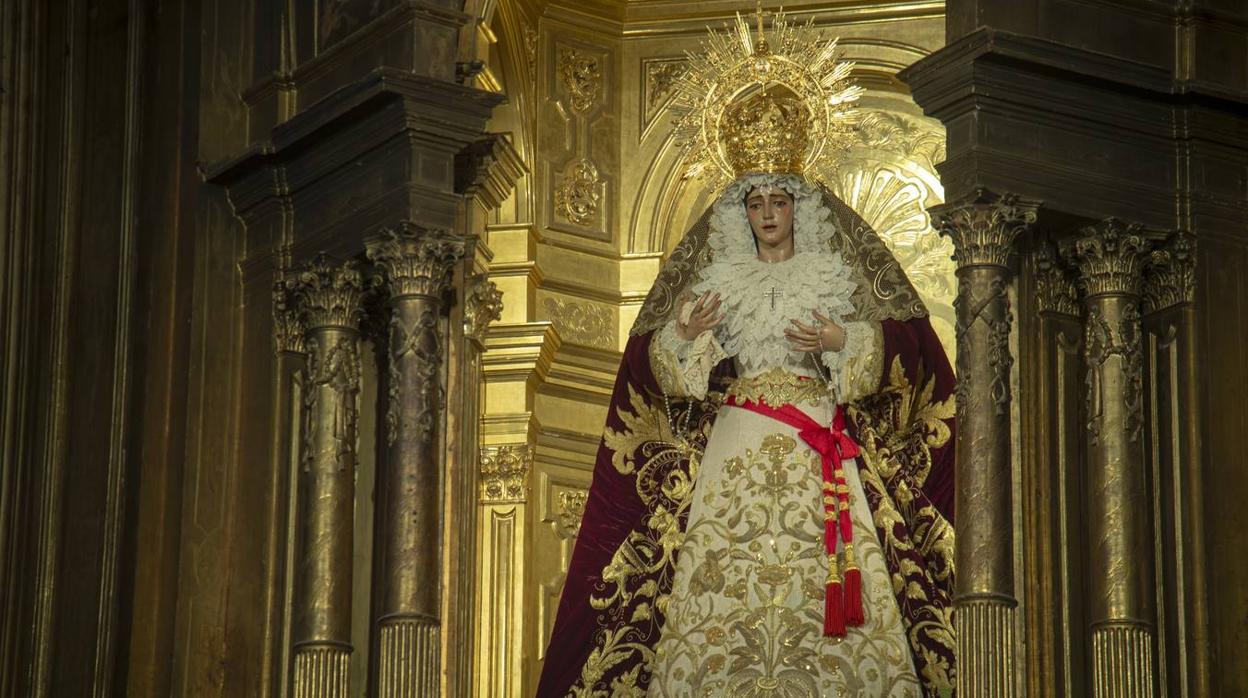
[{"x1": 673, "y1": 2, "x2": 862, "y2": 184}]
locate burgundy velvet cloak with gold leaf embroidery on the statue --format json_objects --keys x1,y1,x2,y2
[{"x1": 537, "y1": 317, "x2": 955, "y2": 698}]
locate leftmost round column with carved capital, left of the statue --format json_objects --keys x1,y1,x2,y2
[{"x1": 287, "y1": 255, "x2": 364, "y2": 698}]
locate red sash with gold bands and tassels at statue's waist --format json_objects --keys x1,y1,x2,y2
[{"x1": 726, "y1": 396, "x2": 862, "y2": 637}]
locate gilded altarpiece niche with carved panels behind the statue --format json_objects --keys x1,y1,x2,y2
[{"x1": 475, "y1": 2, "x2": 957, "y2": 698}]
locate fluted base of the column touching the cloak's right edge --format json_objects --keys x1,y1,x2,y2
[{"x1": 953, "y1": 597, "x2": 1016, "y2": 698}]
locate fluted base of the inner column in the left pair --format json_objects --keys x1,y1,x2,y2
[{"x1": 377, "y1": 616, "x2": 442, "y2": 698}]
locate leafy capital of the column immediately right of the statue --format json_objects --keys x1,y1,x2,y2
[{"x1": 931, "y1": 189, "x2": 1040, "y2": 268}]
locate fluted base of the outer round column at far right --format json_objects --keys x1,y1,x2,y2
[{"x1": 1092, "y1": 623, "x2": 1156, "y2": 698}]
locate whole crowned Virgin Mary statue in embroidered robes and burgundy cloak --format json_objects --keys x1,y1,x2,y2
[{"x1": 538, "y1": 8, "x2": 955, "y2": 697}]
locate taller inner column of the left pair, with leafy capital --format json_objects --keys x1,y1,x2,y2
[{"x1": 368, "y1": 227, "x2": 464, "y2": 698}]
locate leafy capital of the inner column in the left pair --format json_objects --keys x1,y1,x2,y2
[{"x1": 368, "y1": 225, "x2": 467, "y2": 297}]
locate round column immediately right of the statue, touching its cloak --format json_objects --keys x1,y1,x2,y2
[{"x1": 932, "y1": 191, "x2": 1038, "y2": 697}]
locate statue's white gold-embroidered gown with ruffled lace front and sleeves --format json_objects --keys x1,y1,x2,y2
[{"x1": 649, "y1": 252, "x2": 921, "y2": 698}]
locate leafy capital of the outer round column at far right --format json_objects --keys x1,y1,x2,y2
[{"x1": 1062, "y1": 219, "x2": 1152, "y2": 296}]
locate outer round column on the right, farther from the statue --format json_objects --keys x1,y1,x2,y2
[{"x1": 1062, "y1": 219, "x2": 1157, "y2": 697}]
